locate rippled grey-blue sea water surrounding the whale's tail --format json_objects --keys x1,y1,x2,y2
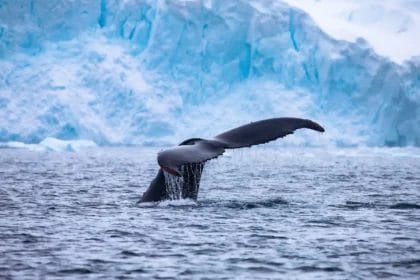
[{"x1": 0, "y1": 146, "x2": 420, "y2": 279}]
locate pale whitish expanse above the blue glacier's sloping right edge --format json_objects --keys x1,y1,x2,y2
[{"x1": 284, "y1": 0, "x2": 420, "y2": 64}]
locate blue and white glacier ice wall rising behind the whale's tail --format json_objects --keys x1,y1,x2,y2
[{"x1": 0, "y1": 0, "x2": 420, "y2": 146}]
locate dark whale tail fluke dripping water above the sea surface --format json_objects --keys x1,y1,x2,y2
[{"x1": 139, "y1": 117, "x2": 325, "y2": 202}]
